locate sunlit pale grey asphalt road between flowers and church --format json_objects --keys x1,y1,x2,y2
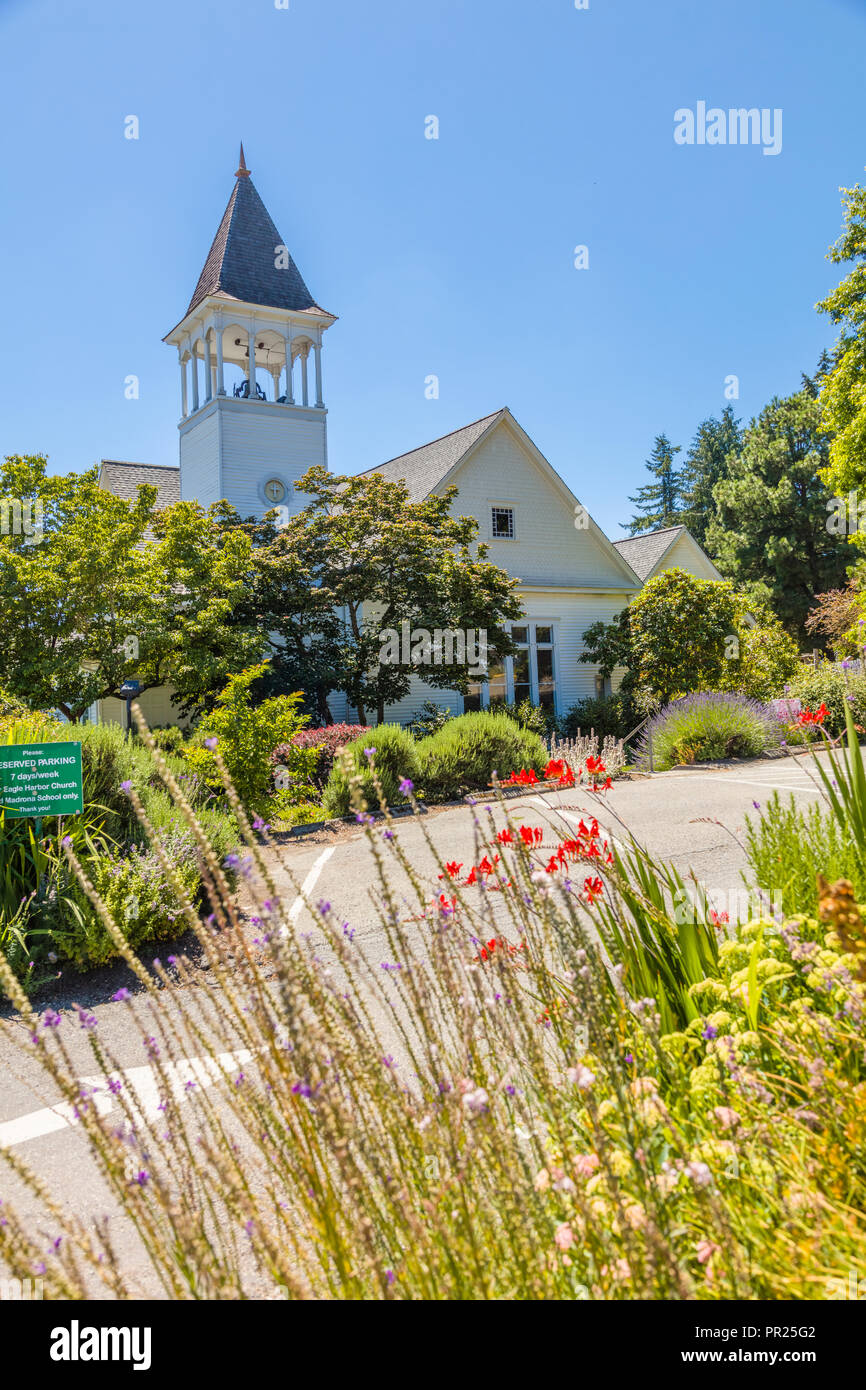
[{"x1": 0, "y1": 758, "x2": 834, "y2": 1294}]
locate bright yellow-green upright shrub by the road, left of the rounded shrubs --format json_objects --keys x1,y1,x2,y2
[{"x1": 185, "y1": 662, "x2": 316, "y2": 815}]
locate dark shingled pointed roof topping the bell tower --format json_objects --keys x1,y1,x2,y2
[{"x1": 186, "y1": 145, "x2": 331, "y2": 317}]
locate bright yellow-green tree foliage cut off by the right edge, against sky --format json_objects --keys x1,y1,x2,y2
[{"x1": 817, "y1": 173, "x2": 866, "y2": 496}]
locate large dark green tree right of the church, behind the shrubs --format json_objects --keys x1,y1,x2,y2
[{"x1": 708, "y1": 384, "x2": 849, "y2": 641}]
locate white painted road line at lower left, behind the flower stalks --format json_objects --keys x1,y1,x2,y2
[{"x1": 0, "y1": 1048, "x2": 253, "y2": 1148}]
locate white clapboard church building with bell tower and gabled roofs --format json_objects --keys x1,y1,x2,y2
[{"x1": 94, "y1": 146, "x2": 721, "y2": 724}]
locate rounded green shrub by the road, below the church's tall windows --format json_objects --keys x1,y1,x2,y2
[{"x1": 418, "y1": 712, "x2": 548, "y2": 801}]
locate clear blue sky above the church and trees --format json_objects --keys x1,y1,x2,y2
[{"x1": 0, "y1": 0, "x2": 866, "y2": 537}]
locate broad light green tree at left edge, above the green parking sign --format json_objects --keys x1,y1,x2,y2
[{"x1": 0, "y1": 456, "x2": 261, "y2": 720}]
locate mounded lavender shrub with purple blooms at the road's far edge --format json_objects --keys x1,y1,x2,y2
[{"x1": 638, "y1": 691, "x2": 781, "y2": 771}]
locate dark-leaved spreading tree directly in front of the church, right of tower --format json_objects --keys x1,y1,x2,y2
[{"x1": 250, "y1": 467, "x2": 521, "y2": 724}]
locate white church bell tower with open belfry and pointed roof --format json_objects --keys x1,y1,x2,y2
[{"x1": 164, "y1": 145, "x2": 336, "y2": 516}]
